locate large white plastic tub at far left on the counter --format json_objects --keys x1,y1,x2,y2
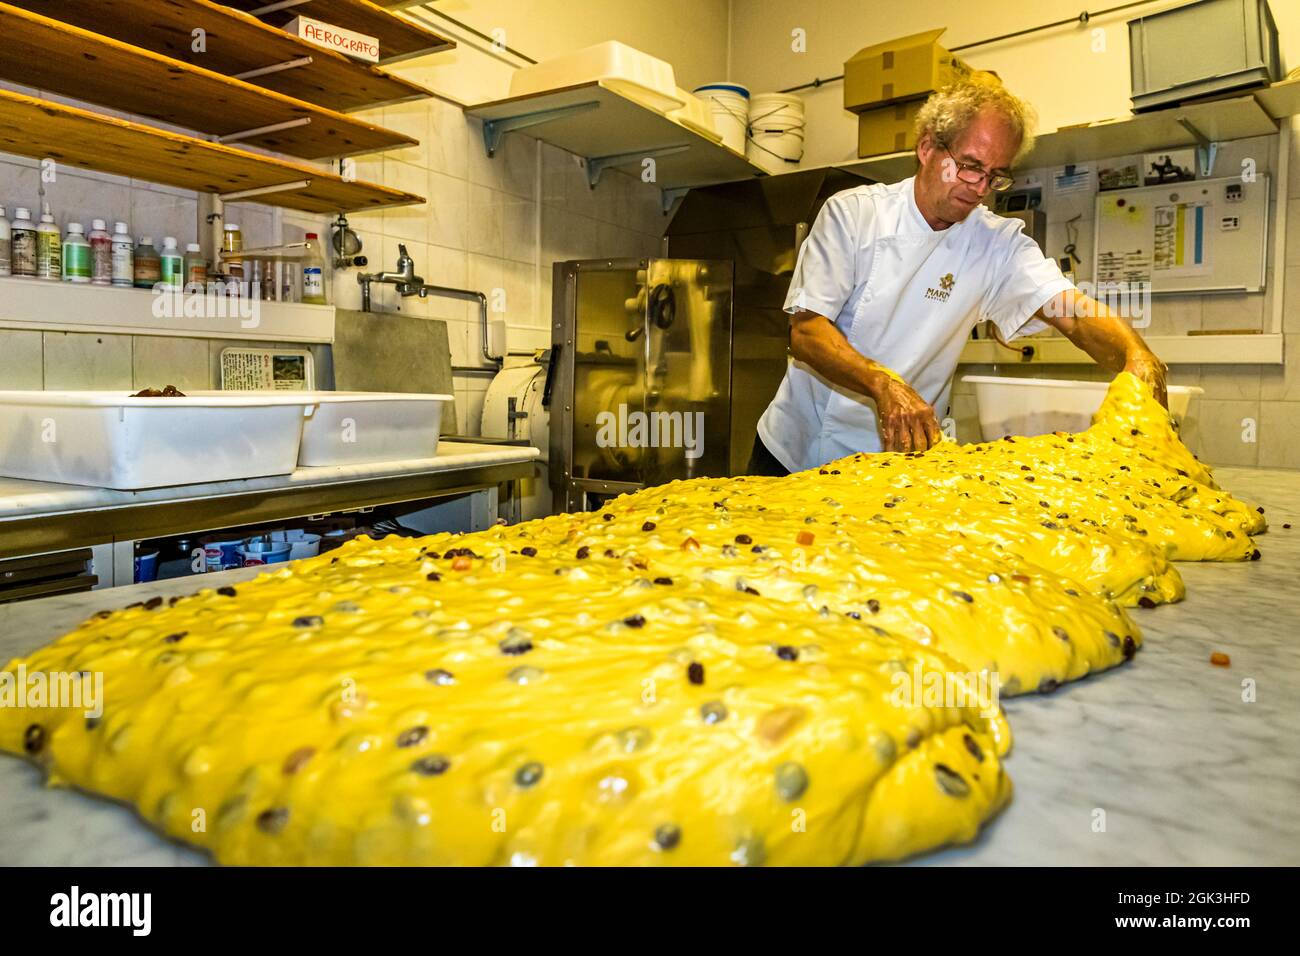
[{"x1": 0, "y1": 389, "x2": 309, "y2": 490}]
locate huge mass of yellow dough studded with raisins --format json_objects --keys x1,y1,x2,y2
[{"x1": 0, "y1": 376, "x2": 1264, "y2": 865}]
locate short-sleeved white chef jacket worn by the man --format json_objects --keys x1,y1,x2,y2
[{"x1": 758, "y1": 177, "x2": 1074, "y2": 471}]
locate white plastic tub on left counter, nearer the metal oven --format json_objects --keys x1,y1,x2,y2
[{"x1": 294, "y1": 392, "x2": 452, "y2": 466}]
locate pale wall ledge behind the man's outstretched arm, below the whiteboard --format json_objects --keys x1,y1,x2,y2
[{"x1": 961, "y1": 333, "x2": 1283, "y2": 365}]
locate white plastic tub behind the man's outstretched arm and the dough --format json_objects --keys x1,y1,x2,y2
[{"x1": 962, "y1": 375, "x2": 1204, "y2": 441}]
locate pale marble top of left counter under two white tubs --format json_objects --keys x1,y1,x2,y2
[{"x1": 0, "y1": 440, "x2": 541, "y2": 522}]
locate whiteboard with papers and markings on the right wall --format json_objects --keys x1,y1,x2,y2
[{"x1": 1092, "y1": 176, "x2": 1269, "y2": 295}]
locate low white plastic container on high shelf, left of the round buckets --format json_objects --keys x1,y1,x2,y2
[{"x1": 510, "y1": 40, "x2": 683, "y2": 112}]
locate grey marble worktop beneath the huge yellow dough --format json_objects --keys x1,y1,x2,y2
[{"x1": 0, "y1": 468, "x2": 1300, "y2": 865}]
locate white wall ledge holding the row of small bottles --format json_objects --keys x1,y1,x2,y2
[{"x1": 0, "y1": 278, "x2": 334, "y2": 342}]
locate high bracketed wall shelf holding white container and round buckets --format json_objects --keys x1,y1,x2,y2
[{"x1": 465, "y1": 82, "x2": 767, "y2": 200}]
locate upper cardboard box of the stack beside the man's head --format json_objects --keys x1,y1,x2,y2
[{"x1": 844, "y1": 29, "x2": 970, "y2": 113}]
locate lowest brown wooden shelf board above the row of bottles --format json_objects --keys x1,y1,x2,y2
[{"x1": 0, "y1": 90, "x2": 424, "y2": 215}]
